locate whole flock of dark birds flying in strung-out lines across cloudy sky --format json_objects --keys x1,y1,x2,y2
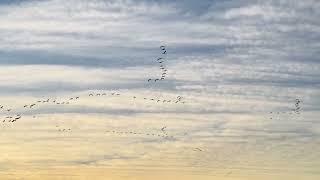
[{"x1": 0, "y1": 46, "x2": 302, "y2": 162}]
